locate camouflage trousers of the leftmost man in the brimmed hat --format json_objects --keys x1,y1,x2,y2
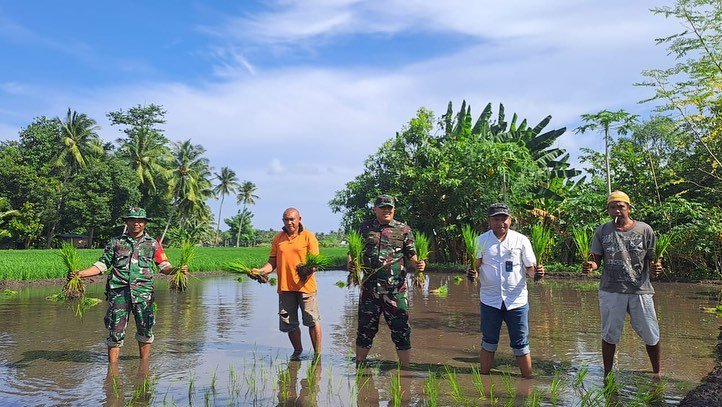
[{"x1": 105, "y1": 287, "x2": 155, "y2": 348}]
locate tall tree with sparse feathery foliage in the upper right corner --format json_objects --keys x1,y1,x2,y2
[{"x1": 638, "y1": 0, "x2": 722, "y2": 195}]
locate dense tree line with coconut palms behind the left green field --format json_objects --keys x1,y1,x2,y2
[{"x1": 0, "y1": 104, "x2": 259, "y2": 248}]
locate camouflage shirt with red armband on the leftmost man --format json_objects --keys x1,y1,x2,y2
[{"x1": 95, "y1": 233, "x2": 170, "y2": 303}]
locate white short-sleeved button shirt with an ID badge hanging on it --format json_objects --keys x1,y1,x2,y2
[{"x1": 476, "y1": 230, "x2": 536, "y2": 309}]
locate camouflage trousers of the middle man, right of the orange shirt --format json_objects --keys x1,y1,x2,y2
[{"x1": 356, "y1": 289, "x2": 411, "y2": 350}]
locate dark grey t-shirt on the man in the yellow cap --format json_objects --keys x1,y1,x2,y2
[{"x1": 591, "y1": 221, "x2": 657, "y2": 294}]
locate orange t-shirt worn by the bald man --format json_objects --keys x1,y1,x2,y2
[{"x1": 271, "y1": 229, "x2": 318, "y2": 294}]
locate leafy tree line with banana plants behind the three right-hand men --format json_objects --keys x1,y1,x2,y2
[{"x1": 330, "y1": 0, "x2": 722, "y2": 279}]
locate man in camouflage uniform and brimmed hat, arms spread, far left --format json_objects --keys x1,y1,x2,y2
[{"x1": 79, "y1": 208, "x2": 188, "y2": 364}]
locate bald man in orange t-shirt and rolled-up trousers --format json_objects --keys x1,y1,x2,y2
[{"x1": 253, "y1": 208, "x2": 321, "y2": 360}]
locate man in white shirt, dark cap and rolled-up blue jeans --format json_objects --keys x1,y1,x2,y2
[{"x1": 469, "y1": 203, "x2": 544, "y2": 378}]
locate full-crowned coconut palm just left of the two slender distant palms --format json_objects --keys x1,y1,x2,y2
[{"x1": 160, "y1": 140, "x2": 213, "y2": 242}]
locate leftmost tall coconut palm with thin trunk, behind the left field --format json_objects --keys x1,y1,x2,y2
[{"x1": 47, "y1": 108, "x2": 104, "y2": 249}]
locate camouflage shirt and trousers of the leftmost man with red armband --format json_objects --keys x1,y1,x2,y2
[{"x1": 95, "y1": 233, "x2": 170, "y2": 347}]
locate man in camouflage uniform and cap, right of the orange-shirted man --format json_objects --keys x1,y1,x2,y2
[{"x1": 348, "y1": 195, "x2": 426, "y2": 366}]
